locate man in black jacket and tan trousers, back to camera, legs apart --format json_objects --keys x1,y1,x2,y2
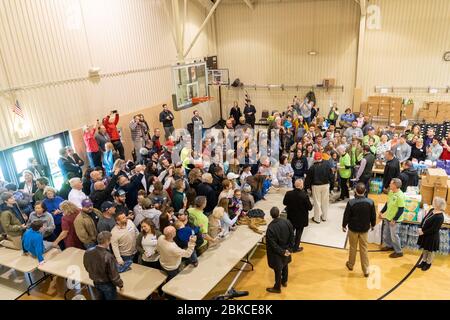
[{"x1": 342, "y1": 183, "x2": 377, "y2": 277}]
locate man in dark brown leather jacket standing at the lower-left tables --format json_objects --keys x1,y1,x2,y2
[{"x1": 83, "y1": 231, "x2": 123, "y2": 300}]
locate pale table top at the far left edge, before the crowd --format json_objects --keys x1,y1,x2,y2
[{"x1": 0, "y1": 247, "x2": 59, "y2": 273}]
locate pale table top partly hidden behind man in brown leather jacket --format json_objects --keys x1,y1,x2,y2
[{"x1": 39, "y1": 248, "x2": 167, "y2": 300}]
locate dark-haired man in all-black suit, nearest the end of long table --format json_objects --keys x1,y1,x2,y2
[{"x1": 266, "y1": 207, "x2": 294, "y2": 293}]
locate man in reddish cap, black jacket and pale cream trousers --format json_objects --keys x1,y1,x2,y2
[{"x1": 305, "y1": 152, "x2": 333, "y2": 224}]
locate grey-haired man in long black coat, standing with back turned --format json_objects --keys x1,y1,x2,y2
[{"x1": 283, "y1": 179, "x2": 312, "y2": 252}]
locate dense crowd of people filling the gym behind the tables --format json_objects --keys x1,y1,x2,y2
[{"x1": 0, "y1": 94, "x2": 442, "y2": 299}]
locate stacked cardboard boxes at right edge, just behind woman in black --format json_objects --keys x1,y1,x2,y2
[{"x1": 420, "y1": 168, "x2": 448, "y2": 205}]
